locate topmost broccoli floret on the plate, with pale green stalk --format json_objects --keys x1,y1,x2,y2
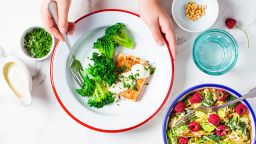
[{"x1": 105, "y1": 23, "x2": 134, "y2": 48}]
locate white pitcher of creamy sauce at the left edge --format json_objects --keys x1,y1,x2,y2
[{"x1": 0, "y1": 47, "x2": 32, "y2": 106}]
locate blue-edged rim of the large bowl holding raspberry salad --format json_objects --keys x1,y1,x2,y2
[{"x1": 162, "y1": 84, "x2": 256, "y2": 144}]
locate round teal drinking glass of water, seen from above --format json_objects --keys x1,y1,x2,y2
[{"x1": 193, "y1": 29, "x2": 238, "y2": 75}]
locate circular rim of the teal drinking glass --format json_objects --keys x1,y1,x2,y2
[{"x1": 192, "y1": 29, "x2": 239, "y2": 76}]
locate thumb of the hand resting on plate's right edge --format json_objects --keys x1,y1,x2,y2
[{"x1": 148, "y1": 20, "x2": 164, "y2": 45}]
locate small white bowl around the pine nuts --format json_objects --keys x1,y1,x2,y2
[{"x1": 172, "y1": 0, "x2": 219, "y2": 33}]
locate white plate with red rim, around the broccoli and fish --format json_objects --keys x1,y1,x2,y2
[{"x1": 51, "y1": 9, "x2": 174, "y2": 132}]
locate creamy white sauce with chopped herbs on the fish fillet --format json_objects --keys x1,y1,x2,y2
[{"x1": 108, "y1": 64, "x2": 150, "y2": 94}]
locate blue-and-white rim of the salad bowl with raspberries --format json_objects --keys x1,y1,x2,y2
[{"x1": 162, "y1": 83, "x2": 256, "y2": 144}]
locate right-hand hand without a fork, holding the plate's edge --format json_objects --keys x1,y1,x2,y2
[{"x1": 139, "y1": 0, "x2": 176, "y2": 58}]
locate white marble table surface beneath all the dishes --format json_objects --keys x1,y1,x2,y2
[{"x1": 0, "y1": 0, "x2": 256, "y2": 144}]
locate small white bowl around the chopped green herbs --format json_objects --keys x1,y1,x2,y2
[{"x1": 20, "y1": 26, "x2": 55, "y2": 61}]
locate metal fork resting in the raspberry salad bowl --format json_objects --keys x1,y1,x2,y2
[{"x1": 174, "y1": 87, "x2": 256, "y2": 127}]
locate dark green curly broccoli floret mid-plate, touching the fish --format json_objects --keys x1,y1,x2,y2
[{"x1": 87, "y1": 52, "x2": 117, "y2": 86}]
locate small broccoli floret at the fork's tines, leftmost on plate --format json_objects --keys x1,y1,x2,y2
[{"x1": 76, "y1": 75, "x2": 95, "y2": 96}]
